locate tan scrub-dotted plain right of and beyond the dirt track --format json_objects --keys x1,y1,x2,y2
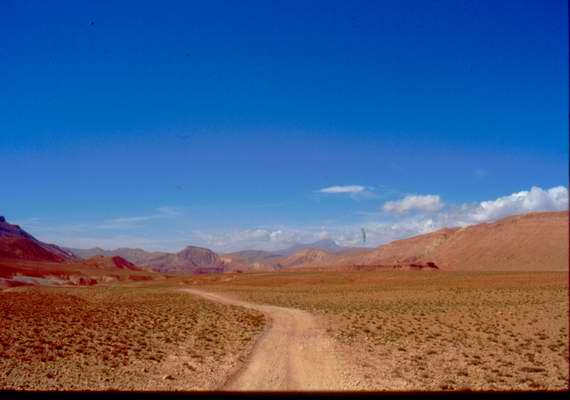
[{"x1": 193, "y1": 272, "x2": 568, "y2": 390}]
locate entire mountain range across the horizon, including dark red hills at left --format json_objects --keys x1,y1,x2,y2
[{"x1": 0, "y1": 212, "x2": 569, "y2": 286}]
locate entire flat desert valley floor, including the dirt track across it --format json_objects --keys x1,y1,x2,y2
[{"x1": 0, "y1": 272, "x2": 568, "y2": 391}]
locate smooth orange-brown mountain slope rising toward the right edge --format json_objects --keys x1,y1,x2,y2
[{"x1": 297, "y1": 212, "x2": 568, "y2": 271}]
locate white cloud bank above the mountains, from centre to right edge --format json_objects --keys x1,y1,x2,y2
[{"x1": 194, "y1": 186, "x2": 568, "y2": 251}]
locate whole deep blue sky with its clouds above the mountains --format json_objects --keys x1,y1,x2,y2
[{"x1": 0, "y1": 0, "x2": 568, "y2": 251}]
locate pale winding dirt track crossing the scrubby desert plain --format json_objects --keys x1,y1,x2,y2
[{"x1": 184, "y1": 289, "x2": 350, "y2": 390}]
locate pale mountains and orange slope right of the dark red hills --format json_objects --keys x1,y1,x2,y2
[{"x1": 70, "y1": 212, "x2": 568, "y2": 272}]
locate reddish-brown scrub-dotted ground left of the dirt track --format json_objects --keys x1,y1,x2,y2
[{"x1": 0, "y1": 284, "x2": 265, "y2": 390}]
